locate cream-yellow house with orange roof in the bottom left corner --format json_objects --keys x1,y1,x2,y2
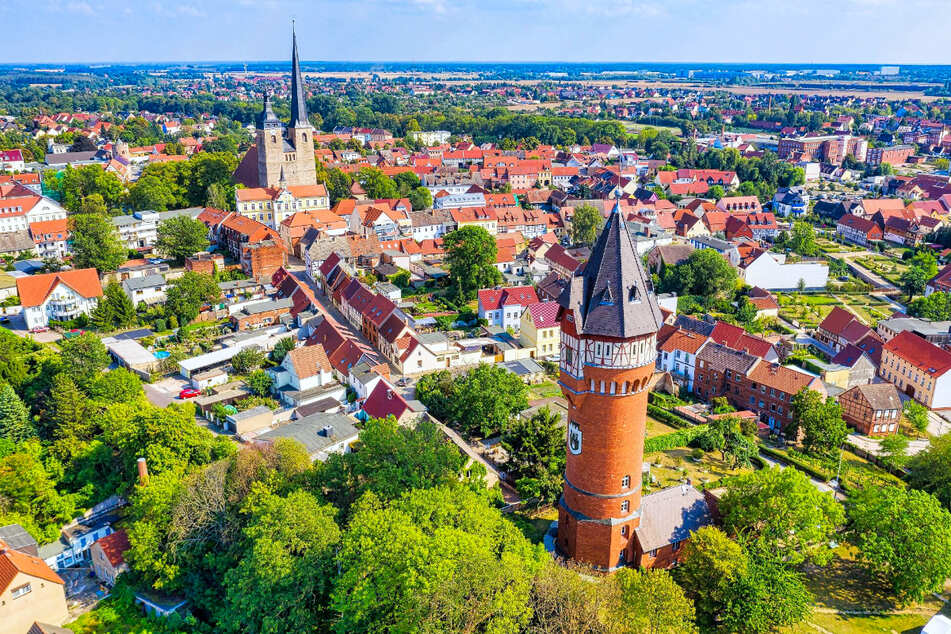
[{"x1": 0, "y1": 542, "x2": 69, "y2": 634}]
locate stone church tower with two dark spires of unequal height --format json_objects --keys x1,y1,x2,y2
[{"x1": 253, "y1": 25, "x2": 317, "y2": 187}]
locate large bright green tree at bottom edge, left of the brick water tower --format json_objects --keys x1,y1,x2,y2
[{"x1": 331, "y1": 487, "x2": 544, "y2": 632}]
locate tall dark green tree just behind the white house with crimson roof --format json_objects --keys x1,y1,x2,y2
[{"x1": 443, "y1": 225, "x2": 502, "y2": 301}]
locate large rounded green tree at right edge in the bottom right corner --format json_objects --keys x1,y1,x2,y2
[{"x1": 849, "y1": 486, "x2": 951, "y2": 601}]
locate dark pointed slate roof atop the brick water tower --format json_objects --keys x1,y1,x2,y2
[{"x1": 559, "y1": 199, "x2": 664, "y2": 339}]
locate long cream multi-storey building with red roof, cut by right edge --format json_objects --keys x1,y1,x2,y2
[{"x1": 878, "y1": 330, "x2": 951, "y2": 409}]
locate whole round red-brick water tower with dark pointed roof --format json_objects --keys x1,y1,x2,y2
[{"x1": 556, "y1": 199, "x2": 663, "y2": 571}]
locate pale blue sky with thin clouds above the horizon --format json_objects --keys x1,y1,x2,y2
[{"x1": 7, "y1": 0, "x2": 951, "y2": 64}]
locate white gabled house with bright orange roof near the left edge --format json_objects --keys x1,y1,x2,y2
[{"x1": 16, "y1": 269, "x2": 102, "y2": 330}]
